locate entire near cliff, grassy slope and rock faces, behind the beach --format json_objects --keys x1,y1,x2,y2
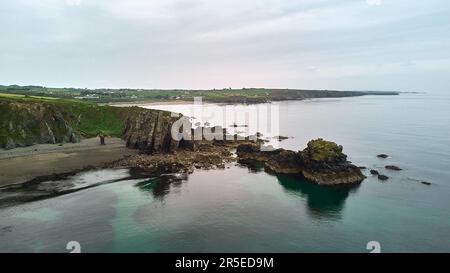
[{"x1": 0, "y1": 95, "x2": 173, "y2": 152}]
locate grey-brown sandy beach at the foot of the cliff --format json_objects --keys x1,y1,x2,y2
[{"x1": 0, "y1": 138, "x2": 137, "y2": 187}]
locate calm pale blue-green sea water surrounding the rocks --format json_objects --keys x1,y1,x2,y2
[{"x1": 0, "y1": 94, "x2": 450, "y2": 252}]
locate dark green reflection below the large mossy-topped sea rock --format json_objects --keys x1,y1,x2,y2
[{"x1": 277, "y1": 175, "x2": 359, "y2": 219}]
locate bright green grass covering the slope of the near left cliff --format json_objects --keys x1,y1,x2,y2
[{"x1": 0, "y1": 93, "x2": 126, "y2": 146}]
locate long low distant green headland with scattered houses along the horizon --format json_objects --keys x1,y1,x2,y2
[{"x1": 0, "y1": 85, "x2": 399, "y2": 103}]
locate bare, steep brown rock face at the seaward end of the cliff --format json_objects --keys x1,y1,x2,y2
[{"x1": 123, "y1": 107, "x2": 180, "y2": 153}]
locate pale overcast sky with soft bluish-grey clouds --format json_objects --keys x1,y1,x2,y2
[{"x1": 0, "y1": 0, "x2": 450, "y2": 92}]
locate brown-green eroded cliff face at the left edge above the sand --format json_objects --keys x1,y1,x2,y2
[{"x1": 0, "y1": 101, "x2": 79, "y2": 149}]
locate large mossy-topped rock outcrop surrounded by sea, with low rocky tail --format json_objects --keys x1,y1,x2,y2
[{"x1": 236, "y1": 139, "x2": 366, "y2": 185}]
